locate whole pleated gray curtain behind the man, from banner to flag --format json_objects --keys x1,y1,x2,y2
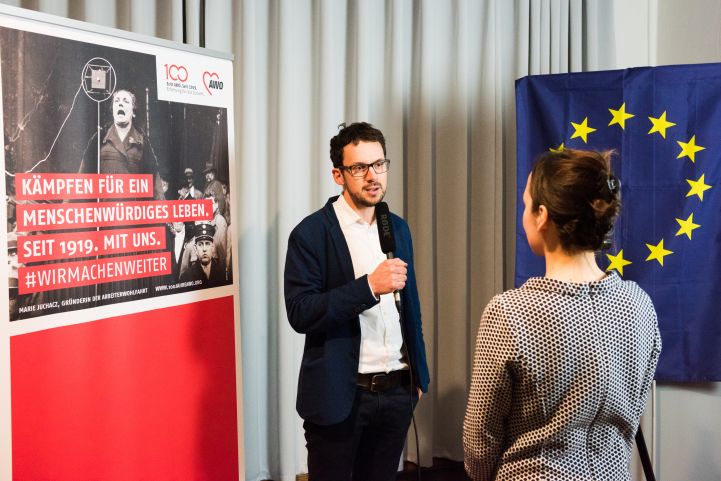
[{"x1": 3, "y1": 0, "x2": 615, "y2": 481}]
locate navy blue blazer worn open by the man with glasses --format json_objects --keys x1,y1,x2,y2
[{"x1": 284, "y1": 197, "x2": 429, "y2": 425}]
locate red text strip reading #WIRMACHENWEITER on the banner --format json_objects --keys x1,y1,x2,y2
[{"x1": 18, "y1": 252, "x2": 172, "y2": 294}]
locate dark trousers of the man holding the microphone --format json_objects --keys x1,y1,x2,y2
[{"x1": 303, "y1": 384, "x2": 418, "y2": 481}]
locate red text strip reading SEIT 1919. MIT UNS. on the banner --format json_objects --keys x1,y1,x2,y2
[{"x1": 18, "y1": 227, "x2": 165, "y2": 263}]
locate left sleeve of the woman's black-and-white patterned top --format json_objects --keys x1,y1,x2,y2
[{"x1": 463, "y1": 296, "x2": 515, "y2": 481}]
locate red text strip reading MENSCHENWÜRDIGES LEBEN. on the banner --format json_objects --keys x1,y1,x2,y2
[{"x1": 17, "y1": 199, "x2": 213, "y2": 232}]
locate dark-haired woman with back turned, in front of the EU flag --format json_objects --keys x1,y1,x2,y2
[{"x1": 463, "y1": 150, "x2": 661, "y2": 481}]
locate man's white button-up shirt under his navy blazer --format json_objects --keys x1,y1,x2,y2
[{"x1": 333, "y1": 195, "x2": 408, "y2": 373}]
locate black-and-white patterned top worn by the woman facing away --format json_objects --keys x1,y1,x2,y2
[{"x1": 463, "y1": 273, "x2": 661, "y2": 481}]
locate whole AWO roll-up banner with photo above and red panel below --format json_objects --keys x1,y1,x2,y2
[{"x1": 0, "y1": 7, "x2": 243, "y2": 481}]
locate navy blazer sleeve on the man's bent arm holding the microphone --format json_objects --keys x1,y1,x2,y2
[{"x1": 284, "y1": 222, "x2": 379, "y2": 334}]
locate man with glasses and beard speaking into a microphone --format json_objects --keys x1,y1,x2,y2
[{"x1": 285, "y1": 122, "x2": 429, "y2": 481}]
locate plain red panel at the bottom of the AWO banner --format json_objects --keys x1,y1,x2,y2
[{"x1": 10, "y1": 297, "x2": 239, "y2": 481}]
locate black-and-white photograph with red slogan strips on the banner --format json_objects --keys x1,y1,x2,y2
[{"x1": 0, "y1": 27, "x2": 233, "y2": 321}]
